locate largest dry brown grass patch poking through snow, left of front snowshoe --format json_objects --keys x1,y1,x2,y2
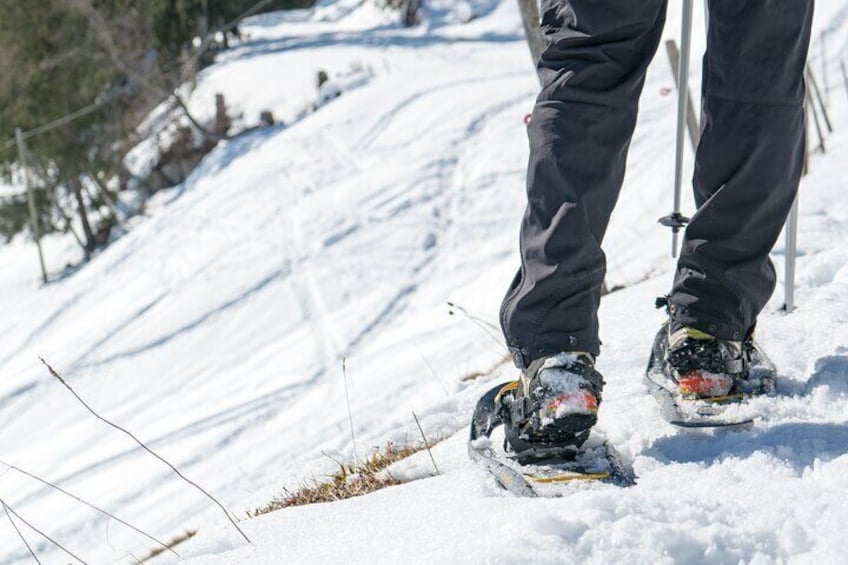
[{"x1": 247, "y1": 442, "x2": 430, "y2": 518}]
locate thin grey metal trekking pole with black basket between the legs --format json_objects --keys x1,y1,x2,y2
[{"x1": 659, "y1": 0, "x2": 693, "y2": 257}]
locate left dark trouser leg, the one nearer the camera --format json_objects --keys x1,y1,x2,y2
[{"x1": 501, "y1": 0, "x2": 666, "y2": 367}]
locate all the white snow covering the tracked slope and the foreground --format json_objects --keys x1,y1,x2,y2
[{"x1": 0, "y1": 0, "x2": 848, "y2": 564}]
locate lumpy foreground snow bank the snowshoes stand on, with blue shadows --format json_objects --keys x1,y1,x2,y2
[{"x1": 179, "y1": 135, "x2": 848, "y2": 565}]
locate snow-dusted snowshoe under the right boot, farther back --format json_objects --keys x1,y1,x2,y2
[{"x1": 644, "y1": 334, "x2": 777, "y2": 428}]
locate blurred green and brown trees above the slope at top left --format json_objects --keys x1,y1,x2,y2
[{"x1": 0, "y1": 0, "x2": 322, "y2": 257}]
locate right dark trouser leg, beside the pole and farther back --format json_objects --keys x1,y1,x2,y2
[{"x1": 669, "y1": 0, "x2": 813, "y2": 341}]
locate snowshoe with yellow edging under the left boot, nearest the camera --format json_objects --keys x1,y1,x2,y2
[{"x1": 468, "y1": 383, "x2": 636, "y2": 496}]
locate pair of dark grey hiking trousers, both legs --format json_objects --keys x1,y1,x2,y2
[{"x1": 501, "y1": 0, "x2": 813, "y2": 366}]
